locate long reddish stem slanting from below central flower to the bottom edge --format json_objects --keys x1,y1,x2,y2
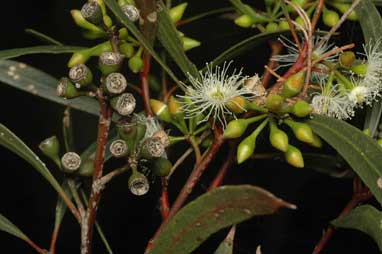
[{"x1": 145, "y1": 127, "x2": 224, "y2": 253}]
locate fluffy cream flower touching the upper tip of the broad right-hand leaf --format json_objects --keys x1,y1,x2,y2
[{"x1": 311, "y1": 80, "x2": 354, "y2": 119}]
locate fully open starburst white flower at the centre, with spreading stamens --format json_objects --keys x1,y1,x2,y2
[{"x1": 179, "y1": 61, "x2": 256, "y2": 126}]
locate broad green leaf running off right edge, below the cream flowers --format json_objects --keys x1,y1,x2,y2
[{"x1": 307, "y1": 115, "x2": 382, "y2": 203}]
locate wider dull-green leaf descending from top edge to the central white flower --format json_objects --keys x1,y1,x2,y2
[{"x1": 158, "y1": 2, "x2": 200, "y2": 82}]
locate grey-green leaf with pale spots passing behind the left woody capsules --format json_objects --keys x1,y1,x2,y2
[{"x1": 0, "y1": 60, "x2": 99, "y2": 115}]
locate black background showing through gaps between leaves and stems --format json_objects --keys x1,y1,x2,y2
[{"x1": 0, "y1": 0, "x2": 378, "y2": 254}]
